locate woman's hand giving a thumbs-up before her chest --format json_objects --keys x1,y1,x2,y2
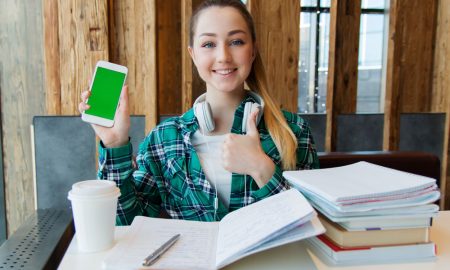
[{"x1": 222, "y1": 110, "x2": 275, "y2": 187}]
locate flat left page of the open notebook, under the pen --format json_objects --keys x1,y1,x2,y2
[{"x1": 103, "y1": 216, "x2": 219, "y2": 270}]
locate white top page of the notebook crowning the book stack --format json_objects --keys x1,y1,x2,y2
[{"x1": 283, "y1": 162, "x2": 436, "y2": 202}]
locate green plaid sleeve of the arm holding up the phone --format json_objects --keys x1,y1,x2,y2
[{"x1": 97, "y1": 139, "x2": 161, "y2": 225}]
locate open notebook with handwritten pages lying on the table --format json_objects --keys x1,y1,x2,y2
[{"x1": 103, "y1": 189, "x2": 325, "y2": 269}]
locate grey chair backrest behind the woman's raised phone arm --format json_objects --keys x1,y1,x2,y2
[{"x1": 33, "y1": 116, "x2": 145, "y2": 209}]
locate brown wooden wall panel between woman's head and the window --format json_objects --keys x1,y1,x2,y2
[{"x1": 249, "y1": 0, "x2": 300, "y2": 112}]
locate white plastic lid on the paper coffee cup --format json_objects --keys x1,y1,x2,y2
[{"x1": 68, "y1": 180, "x2": 120, "y2": 199}]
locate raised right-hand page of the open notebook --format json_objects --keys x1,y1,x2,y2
[{"x1": 216, "y1": 189, "x2": 314, "y2": 266}]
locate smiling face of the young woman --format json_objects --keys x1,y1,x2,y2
[{"x1": 189, "y1": 7, "x2": 256, "y2": 92}]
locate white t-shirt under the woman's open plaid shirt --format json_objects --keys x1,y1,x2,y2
[{"x1": 191, "y1": 130, "x2": 231, "y2": 207}]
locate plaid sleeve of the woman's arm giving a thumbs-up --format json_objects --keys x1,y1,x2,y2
[{"x1": 252, "y1": 112, "x2": 319, "y2": 201}]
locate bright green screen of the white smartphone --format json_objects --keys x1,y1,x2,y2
[{"x1": 85, "y1": 67, "x2": 125, "y2": 120}]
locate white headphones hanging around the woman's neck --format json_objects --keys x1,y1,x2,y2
[{"x1": 194, "y1": 91, "x2": 264, "y2": 133}]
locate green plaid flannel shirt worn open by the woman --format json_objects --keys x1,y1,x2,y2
[{"x1": 98, "y1": 96, "x2": 319, "y2": 225}]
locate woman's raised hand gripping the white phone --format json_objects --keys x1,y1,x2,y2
[{"x1": 78, "y1": 86, "x2": 130, "y2": 148}]
